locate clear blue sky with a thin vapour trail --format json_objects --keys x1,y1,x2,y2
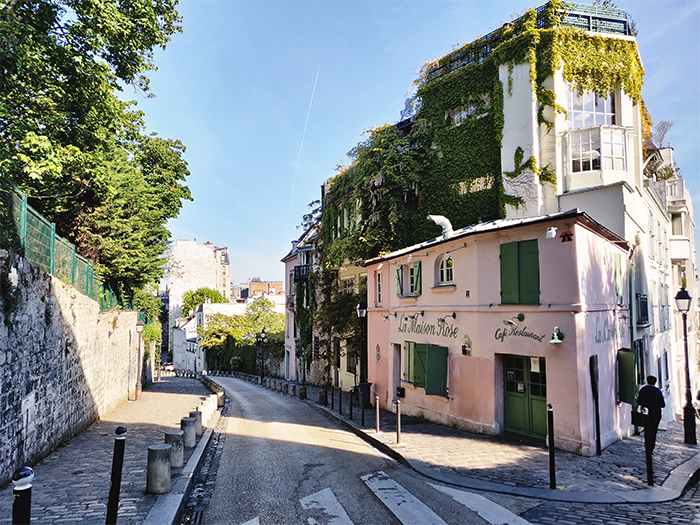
[{"x1": 133, "y1": 0, "x2": 700, "y2": 283}]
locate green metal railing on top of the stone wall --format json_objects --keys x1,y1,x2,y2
[{"x1": 0, "y1": 182, "x2": 119, "y2": 312}]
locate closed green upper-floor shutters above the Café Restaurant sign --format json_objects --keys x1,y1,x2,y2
[{"x1": 500, "y1": 239, "x2": 540, "y2": 304}]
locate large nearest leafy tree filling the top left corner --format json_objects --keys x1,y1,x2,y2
[{"x1": 0, "y1": 0, "x2": 181, "y2": 240}]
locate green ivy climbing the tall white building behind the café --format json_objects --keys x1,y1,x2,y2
[{"x1": 297, "y1": 0, "x2": 650, "y2": 384}]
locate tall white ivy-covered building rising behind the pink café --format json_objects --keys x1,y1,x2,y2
[{"x1": 284, "y1": 0, "x2": 698, "y2": 434}]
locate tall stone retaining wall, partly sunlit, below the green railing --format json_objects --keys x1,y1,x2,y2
[{"x1": 0, "y1": 258, "x2": 145, "y2": 485}]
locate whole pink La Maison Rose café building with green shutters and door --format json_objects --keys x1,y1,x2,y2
[{"x1": 367, "y1": 210, "x2": 636, "y2": 455}]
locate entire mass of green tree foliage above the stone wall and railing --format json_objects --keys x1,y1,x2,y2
[{"x1": 0, "y1": 0, "x2": 191, "y2": 301}]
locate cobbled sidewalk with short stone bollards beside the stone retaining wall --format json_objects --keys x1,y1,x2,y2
[{"x1": 0, "y1": 377, "x2": 216, "y2": 525}]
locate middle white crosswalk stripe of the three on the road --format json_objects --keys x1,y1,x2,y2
[{"x1": 362, "y1": 470, "x2": 447, "y2": 525}]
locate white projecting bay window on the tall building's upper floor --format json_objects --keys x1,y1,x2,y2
[{"x1": 563, "y1": 124, "x2": 629, "y2": 191}]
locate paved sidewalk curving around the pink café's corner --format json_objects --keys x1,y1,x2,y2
[{"x1": 221, "y1": 377, "x2": 700, "y2": 503}]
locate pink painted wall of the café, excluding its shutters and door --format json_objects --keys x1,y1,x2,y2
[{"x1": 367, "y1": 218, "x2": 629, "y2": 455}]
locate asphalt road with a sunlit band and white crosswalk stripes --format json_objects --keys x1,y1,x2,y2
[{"x1": 203, "y1": 378, "x2": 524, "y2": 525}]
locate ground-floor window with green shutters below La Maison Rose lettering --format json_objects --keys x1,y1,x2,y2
[{"x1": 403, "y1": 341, "x2": 449, "y2": 397}]
